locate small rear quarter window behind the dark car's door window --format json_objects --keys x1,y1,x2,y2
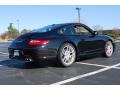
[{"x1": 58, "y1": 26, "x2": 75, "y2": 35}]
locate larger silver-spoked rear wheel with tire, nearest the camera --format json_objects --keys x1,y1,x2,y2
[{"x1": 57, "y1": 43, "x2": 76, "y2": 67}]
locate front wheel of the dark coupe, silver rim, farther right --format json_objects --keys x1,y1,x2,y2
[{"x1": 104, "y1": 41, "x2": 114, "y2": 57}]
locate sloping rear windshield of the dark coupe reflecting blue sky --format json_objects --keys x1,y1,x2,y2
[{"x1": 31, "y1": 24, "x2": 59, "y2": 33}]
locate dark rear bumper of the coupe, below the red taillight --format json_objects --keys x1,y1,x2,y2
[{"x1": 8, "y1": 48, "x2": 57, "y2": 61}]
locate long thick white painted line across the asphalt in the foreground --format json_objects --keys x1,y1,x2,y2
[{"x1": 51, "y1": 63, "x2": 120, "y2": 85}]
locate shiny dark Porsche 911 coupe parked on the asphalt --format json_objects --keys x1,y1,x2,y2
[{"x1": 8, "y1": 23, "x2": 115, "y2": 67}]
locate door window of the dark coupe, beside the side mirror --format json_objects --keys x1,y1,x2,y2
[{"x1": 74, "y1": 26, "x2": 91, "y2": 35}]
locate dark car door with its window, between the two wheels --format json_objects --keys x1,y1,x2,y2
[{"x1": 74, "y1": 25, "x2": 103, "y2": 54}]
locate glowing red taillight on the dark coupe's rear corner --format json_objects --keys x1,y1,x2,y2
[{"x1": 29, "y1": 40, "x2": 49, "y2": 46}]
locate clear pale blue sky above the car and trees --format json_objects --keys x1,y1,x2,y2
[{"x1": 0, "y1": 5, "x2": 120, "y2": 34}]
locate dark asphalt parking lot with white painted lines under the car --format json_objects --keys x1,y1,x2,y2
[{"x1": 0, "y1": 43, "x2": 120, "y2": 85}]
